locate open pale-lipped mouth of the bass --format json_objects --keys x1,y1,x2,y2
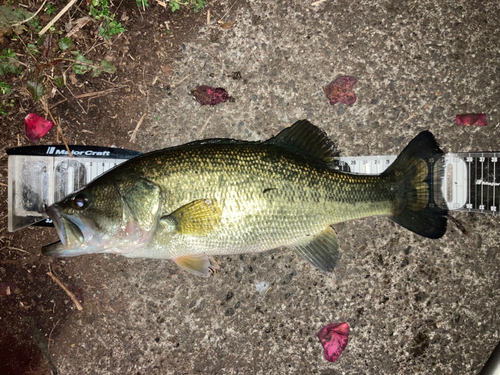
[{"x1": 42, "y1": 204, "x2": 94, "y2": 257}]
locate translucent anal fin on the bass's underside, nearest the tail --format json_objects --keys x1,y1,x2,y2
[{"x1": 292, "y1": 227, "x2": 340, "y2": 272}]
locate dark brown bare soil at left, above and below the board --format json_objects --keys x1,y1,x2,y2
[{"x1": 0, "y1": 0, "x2": 228, "y2": 374}]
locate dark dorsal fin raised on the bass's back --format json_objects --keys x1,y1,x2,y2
[{"x1": 264, "y1": 120, "x2": 339, "y2": 164}]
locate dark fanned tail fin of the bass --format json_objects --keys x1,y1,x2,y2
[{"x1": 382, "y1": 131, "x2": 448, "y2": 238}]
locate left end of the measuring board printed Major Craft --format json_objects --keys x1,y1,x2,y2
[{"x1": 7, "y1": 145, "x2": 141, "y2": 232}]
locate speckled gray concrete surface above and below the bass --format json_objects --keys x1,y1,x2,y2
[{"x1": 51, "y1": 0, "x2": 500, "y2": 375}]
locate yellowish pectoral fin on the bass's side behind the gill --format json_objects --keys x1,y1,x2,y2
[{"x1": 161, "y1": 199, "x2": 222, "y2": 236}]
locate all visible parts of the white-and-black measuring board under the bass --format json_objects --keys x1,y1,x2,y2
[{"x1": 7, "y1": 145, "x2": 500, "y2": 232}]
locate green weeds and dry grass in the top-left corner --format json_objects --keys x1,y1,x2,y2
[{"x1": 0, "y1": 0, "x2": 206, "y2": 115}]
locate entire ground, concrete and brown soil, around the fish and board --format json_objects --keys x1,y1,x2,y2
[{"x1": 0, "y1": 0, "x2": 500, "y2": 375}]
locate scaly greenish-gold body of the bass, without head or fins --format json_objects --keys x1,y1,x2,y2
[{"x1": 118, "y1": 144, "x2": 393, "y2": 258}]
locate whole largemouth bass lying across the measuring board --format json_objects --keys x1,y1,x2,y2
[{"x1": 43, "y1": 120, "x2": 447, "y2": 276}]
